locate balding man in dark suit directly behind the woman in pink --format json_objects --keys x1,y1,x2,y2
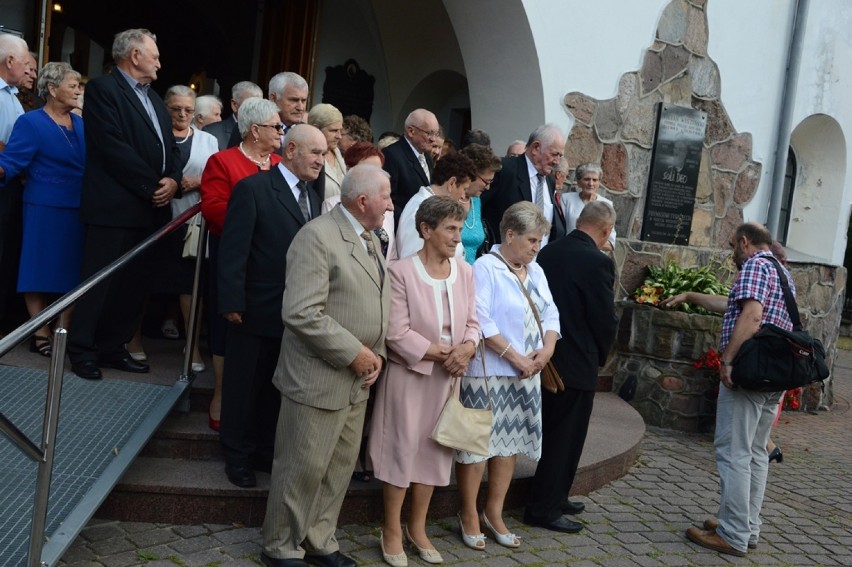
[{"x1": 383, "y1": 108, "x2": 438, "y2": 223}]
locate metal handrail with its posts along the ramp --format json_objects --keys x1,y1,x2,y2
[{"x1": 0, "y1": 203, "x2": 207, "y2": 567}]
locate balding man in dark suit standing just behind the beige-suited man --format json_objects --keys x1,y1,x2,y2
[{"x1": 218, "y1": 124, "x2": 327, "y2": 487}]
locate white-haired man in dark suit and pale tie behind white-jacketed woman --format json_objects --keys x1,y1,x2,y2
[{"x1": 482, "y1": 124, "x2": 565, "y2": 248}]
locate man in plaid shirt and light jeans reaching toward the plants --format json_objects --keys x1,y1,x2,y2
[{"x1": 686, "y1": 223, "x2": 796, "y2": 557}]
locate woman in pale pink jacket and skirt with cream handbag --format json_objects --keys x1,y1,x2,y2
[{"x1": 368, "y1": 196, "x2": 480, "y2": 567}]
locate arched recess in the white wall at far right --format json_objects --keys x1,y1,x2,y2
[{"x1": 787, "y1": 114, "x2": 848, "y2": 262}]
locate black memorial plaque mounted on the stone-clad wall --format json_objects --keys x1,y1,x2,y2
[{"x1": 642, "y1": 103, "x2": 707, "y2": 246}]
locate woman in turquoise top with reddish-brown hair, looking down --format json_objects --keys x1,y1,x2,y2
[{"x1": 460, "y1": 144, "x2": 503, "y2": 265}]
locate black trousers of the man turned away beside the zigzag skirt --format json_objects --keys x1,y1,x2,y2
[{"x1": 525, "y1": 388, "x2": 595, "y2": 522}]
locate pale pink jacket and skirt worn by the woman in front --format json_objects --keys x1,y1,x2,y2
[{"x1": 367, "y1": 254, "x2": 479, "y2": 487}]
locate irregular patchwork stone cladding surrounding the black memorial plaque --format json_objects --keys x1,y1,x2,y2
[{"x1": 564, "y1": 0, "x2": 761, "y2": 250}]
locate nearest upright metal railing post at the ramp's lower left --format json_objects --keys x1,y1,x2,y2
[{"x1": 27, "y1": 327, "x2": 68, "y2": 567}]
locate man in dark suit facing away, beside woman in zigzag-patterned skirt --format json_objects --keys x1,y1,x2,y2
[{"x1": 524, "y1": 201, "x2": 617, "y2": 533}]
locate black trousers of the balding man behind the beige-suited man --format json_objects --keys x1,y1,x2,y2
[{"x1": 219, "y1": 330, "x2": 281, "y2": 466}]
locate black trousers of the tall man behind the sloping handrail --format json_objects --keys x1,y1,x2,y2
[{"x1": 68, "y1": 225, "x2": 154, "y2": 364}]
